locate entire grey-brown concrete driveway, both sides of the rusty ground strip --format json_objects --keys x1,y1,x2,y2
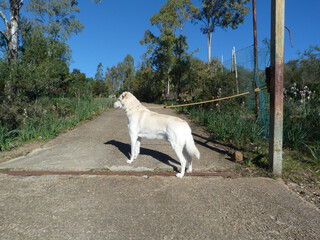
[{"x1": 0, "y1": 105, "x2": 320, "y2": 240}]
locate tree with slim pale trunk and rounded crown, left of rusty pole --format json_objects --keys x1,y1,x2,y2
[{"x1": 196, "y1": 0, "x2": 250, "y2": 64}]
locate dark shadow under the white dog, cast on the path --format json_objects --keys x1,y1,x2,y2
[{"x1": 104, "y1": 140, "x2": 180, "y2": 171}]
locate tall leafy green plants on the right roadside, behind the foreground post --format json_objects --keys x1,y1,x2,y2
[{"x1": 179, "y1": 85, "x2": 320, "y2": 166}]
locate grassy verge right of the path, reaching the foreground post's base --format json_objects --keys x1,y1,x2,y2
[{"x1": 178, "y1": 98, "x2": 320, "y2": 198}]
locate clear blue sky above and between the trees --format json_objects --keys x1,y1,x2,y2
[{"x1": 68, "y1": 0, "x2": 320, "y2": 77}]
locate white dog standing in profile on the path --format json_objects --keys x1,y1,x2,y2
[{"x1": 114, "y1": 92, "x2": 200, "y2": 178}]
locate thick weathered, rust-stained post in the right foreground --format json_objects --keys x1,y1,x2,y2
[{"x1": 269, "y1": 0, "x2": 285, "y2": 175}]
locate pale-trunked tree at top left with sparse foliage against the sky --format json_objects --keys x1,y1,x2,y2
[{"x1": 0, "y1": 0, "x2": 84, "y2": 62}]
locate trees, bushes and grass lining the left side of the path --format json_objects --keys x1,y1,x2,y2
[{"x1": 0, "y1": 0, "x2": 113, "y2": 151}]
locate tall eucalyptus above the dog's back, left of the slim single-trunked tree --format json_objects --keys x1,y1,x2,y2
[{"x1": 144, "y1": 0, "x2": 198, "y2": 97}]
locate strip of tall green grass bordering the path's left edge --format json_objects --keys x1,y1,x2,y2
[{"x1": 0, "y1": 97, "x2": 113, "y2": 151}]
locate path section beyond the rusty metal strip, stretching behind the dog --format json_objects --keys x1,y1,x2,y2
[{"x1": 0, "y1": 104, "x2": 235, "y2": 172}]
